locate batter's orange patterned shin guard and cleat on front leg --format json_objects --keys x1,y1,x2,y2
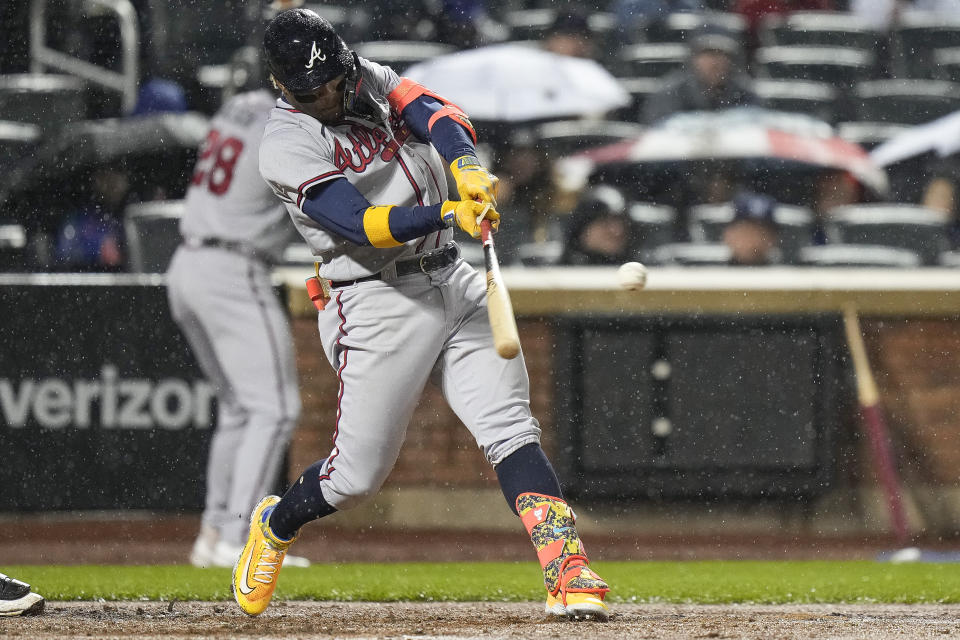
[{"x1": 517, "y1": 493, "x2": 610, "y2": 621}]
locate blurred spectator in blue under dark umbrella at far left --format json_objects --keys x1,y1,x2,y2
[{"x1": 53, "y1": 165, "x2": 130, "y2": 272}]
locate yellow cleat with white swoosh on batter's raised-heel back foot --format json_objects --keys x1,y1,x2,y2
[{"x1": 230, "y1": 496, "x2": 296, "y2": 616}]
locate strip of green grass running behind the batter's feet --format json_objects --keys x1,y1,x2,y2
[{"x1": 2, "y1": 561, "x2": 960, "y2": 604}]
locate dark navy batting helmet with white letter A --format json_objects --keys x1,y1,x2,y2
[{"x1": 263, "y1": 9, "x2": 355, "y2": 94}]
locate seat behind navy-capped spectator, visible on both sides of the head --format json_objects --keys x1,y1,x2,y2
[{"x1": 688, "y1": 202, "x2": 814, "y2": 263}]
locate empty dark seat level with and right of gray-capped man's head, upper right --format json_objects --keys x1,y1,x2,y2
[{"x1": 754, "y1": 46, "x2": 875, "y2": 88}]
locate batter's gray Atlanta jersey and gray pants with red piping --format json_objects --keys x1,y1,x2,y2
[{"x1": 260, "y1": 59, "x2": 540, "y2": 510}]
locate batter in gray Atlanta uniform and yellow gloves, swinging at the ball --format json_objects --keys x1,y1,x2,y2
[{"x1": 232, "y1": 9, "x2": 609, "y2": 619}]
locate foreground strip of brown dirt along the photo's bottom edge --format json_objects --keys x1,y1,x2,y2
[{"x1": 7, "y1": 602, "x2": 960, "y2": 640}]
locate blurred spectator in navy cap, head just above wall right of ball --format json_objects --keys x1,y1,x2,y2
[{"x1": 723, "y1": 191, "x2": 780, "y2": 266}]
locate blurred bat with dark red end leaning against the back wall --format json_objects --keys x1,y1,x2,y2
[{"x1": 843, "y1": 305, "x2": 910, "y2": 544}]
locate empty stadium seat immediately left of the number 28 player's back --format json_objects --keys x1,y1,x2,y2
[{"x1": 123, "y1": 200, "x2": 183, "y2": 273}]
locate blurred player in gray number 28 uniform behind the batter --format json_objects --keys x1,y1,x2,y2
[{"x1": 167, "y1": 90, "x2": 309, "y2": 567}]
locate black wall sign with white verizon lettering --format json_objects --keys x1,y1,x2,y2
[{"x1": 0, "y1": 275, "x2": 216, "y2": 511}]
